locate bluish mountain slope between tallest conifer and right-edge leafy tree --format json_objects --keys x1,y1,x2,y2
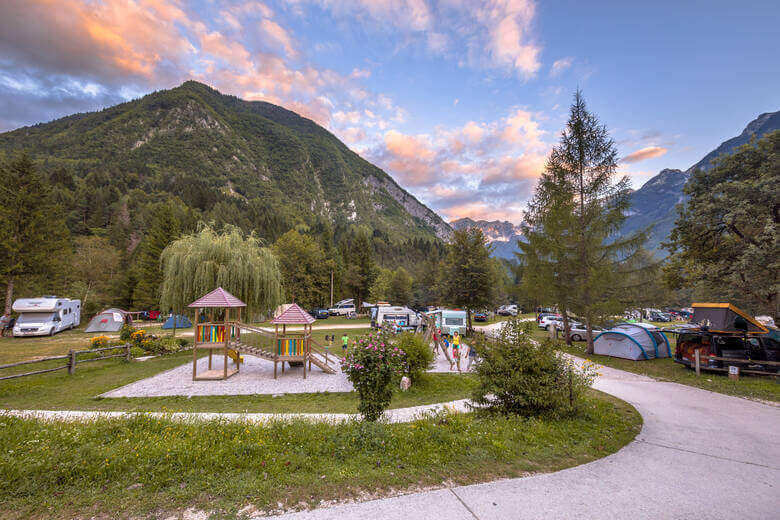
[{"x1": 622, "y1": 111, "x2": 780, "y2": 256}]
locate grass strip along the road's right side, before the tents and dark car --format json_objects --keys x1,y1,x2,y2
[{"x1": 548, "y1": 331, "x2": 780, "y2": 402}]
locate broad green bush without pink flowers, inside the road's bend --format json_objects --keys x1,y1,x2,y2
[{"x1": 472, "y1": 319, "x2": 594, "y2": 415}]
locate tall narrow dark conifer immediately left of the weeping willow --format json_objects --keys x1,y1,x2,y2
[{"x1": 133, "y1": 203, "x2": 182, "y2": 309}]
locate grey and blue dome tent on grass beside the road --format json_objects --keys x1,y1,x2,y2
[{"x1": 593, "y1": 323, "x2": 672, "y2": 360}]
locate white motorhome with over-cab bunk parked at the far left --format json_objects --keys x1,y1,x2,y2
[{"x1": 12, "y1": 296, "x2": 81, "y2": 337}]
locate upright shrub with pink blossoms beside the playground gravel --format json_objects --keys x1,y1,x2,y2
[{"x1": 341, "y1": 332, "x2": 406, "y2": 421}]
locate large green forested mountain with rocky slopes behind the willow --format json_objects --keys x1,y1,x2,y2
[{"x1": 0, "y1": 81, "x2": 452, "y2": 246}]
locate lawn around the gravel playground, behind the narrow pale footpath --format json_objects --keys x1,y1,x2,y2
[{"x1": 0, "y1": 352, "x2": 474, "y2": 413}]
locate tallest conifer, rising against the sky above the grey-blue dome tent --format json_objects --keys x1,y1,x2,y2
[{"x1": 524, "y1": 91, "x2": 647, "y2": 353}]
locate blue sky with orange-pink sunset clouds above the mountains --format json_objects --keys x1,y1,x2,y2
[{"x1": 0, "y1": 0, "x2": 780, "y2": 224}]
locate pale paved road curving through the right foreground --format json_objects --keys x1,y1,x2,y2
[{"x1": 268, "y1": 360, "x2": 780, "y2": 520}]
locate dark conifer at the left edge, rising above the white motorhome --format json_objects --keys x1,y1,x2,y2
[{"x1": 0, "y1": 156, "x2": 70, "y2": 313}]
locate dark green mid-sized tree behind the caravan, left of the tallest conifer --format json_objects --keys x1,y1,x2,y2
[{"x1": 443, "y1": 228, "x2": 496, "y2": 330}]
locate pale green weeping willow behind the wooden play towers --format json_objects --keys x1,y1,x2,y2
[{"x1": 160, "y1": 225, "x2": 283, "y2": 315}]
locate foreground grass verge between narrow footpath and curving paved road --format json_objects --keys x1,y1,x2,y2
[{"x1": 0, "y1": 391, "x2": 641, "y2": 518}]
